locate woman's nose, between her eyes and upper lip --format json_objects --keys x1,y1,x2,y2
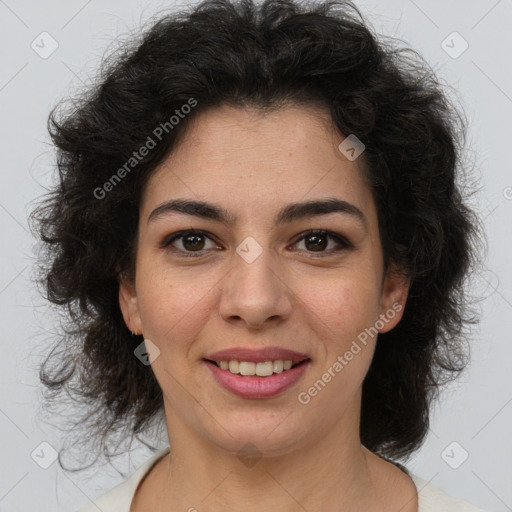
[{"x1": 219, "y1": 249, "x2": 293, "y2": 329}]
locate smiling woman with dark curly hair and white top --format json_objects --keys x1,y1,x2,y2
[{"x1": 30, "y1": 0, "x2": 486, "y2": 512}]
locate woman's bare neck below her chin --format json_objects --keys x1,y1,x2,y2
[{"x1": 148, "y1": 394, "x2": 399, "y2": 512}]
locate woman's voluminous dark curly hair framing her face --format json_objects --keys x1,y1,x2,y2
[{"x1": 31, "y1": 0, "x2": 482, "y2": 465}]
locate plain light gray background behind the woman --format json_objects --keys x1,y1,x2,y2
[{"x1": 0, "y1": 0, "x2": 512, "y2": 512}]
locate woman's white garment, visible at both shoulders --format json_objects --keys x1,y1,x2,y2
[{"x1": 78, "y1": 447, "x2": 485, "y2": 512}]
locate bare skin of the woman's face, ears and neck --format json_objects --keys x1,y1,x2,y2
[{"x1": 119, "y1": 105, "x2": 418, "y2": 512}]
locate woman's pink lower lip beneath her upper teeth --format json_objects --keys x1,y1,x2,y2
[{"x1": 205, "y1": 361, "x2": 311, "y2": 398}]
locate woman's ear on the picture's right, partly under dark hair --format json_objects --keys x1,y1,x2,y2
[{"x1": 377, "y1": 264, "x2": 410, "y2": 334}]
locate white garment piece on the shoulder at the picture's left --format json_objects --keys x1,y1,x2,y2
[{"x1": 78, "y1": 447, "x2": 169, "y2": 512}]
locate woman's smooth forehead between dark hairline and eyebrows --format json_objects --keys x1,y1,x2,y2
[{"x1": 141, "y1": 106, "x2": 375, "y2": 228}]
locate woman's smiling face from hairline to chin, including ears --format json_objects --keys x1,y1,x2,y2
[{"x1": 120, "y1": 107, "x2": 408, "y2": 454}]
